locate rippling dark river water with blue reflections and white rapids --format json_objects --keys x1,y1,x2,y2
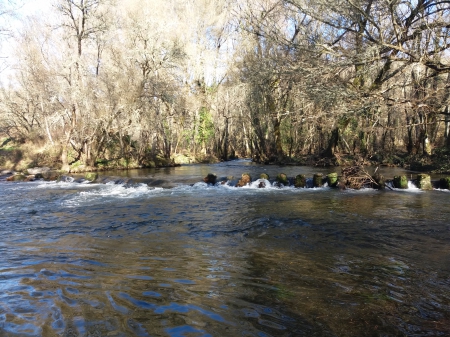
[{"x1": 0, "y1": 161, "x2": 450, "y2": 337}]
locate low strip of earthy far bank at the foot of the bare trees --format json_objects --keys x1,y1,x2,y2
[{"x1": 0, "y1": 139, "x2": 450, "y2": 174}]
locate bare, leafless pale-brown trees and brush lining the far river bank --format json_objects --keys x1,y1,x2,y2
[{"x1": 0, "y1": 0, "x2": 450, "y2": 170}]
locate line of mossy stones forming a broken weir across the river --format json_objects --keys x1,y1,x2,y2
[{"x1": 0, "y1": 166, "x2": 450, "y2": 190}]
